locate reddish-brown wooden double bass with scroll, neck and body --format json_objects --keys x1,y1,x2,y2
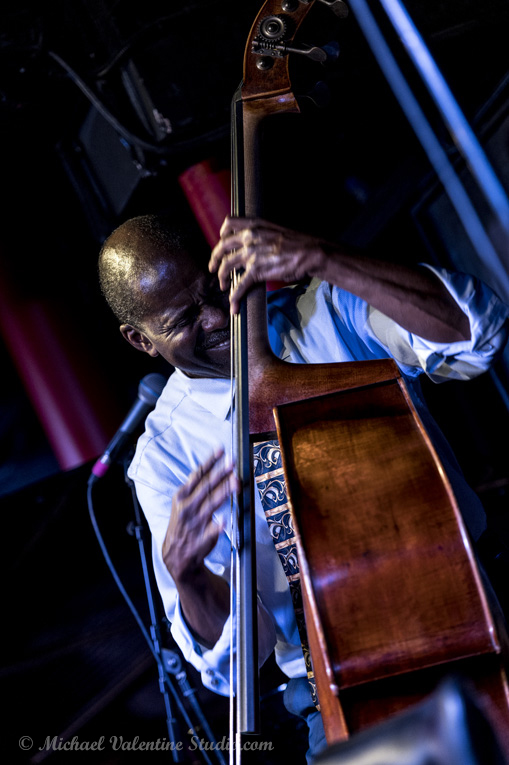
[{"x1": 232, "y1": 0, "x2": 509, "y2": 755}]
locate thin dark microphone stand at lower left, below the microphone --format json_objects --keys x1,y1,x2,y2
[{"x1": 123, "y1": 455, "x2": 226, "y2": 765}]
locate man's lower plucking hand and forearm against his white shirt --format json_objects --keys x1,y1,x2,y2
[{"x1": 162, "y1": 451, "x2": 238, "y2": 645}]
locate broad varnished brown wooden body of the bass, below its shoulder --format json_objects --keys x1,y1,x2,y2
[{"x1": 276, "y1": 380, "x2": 509, "y2": 754}]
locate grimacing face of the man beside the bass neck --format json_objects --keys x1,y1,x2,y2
[{"x1": 121, "y1": 255, "x2": 230, "y2": 377}]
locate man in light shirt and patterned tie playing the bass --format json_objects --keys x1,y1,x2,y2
[{"x1": 99, "y1": 210, "x2": 508, "y2": 751}]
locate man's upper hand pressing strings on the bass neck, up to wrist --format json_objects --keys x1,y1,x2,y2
[{"x1": 209, "y1": 217, "x2": 324, "y2": 313}]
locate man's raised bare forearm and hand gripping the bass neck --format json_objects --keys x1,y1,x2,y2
[{"x1": 209, "y1": 218, "x2": 470, "y2": 343}]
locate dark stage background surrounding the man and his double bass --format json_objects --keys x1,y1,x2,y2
[{"x1": 0, "y1": 0, "x2": 509, "y2": 763}]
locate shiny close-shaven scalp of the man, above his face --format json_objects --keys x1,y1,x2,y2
[{"x1": 98, "y1": 215, "x2": 210, "y2": 327}]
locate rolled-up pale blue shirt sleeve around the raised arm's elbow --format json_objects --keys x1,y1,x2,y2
[{"x1": 344, "y1": 265, "x2": 509, "y2": 382}]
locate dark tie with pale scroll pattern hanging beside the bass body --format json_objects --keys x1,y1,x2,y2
[{"x1": 253, "y1": 439, "x2": 320, "y2": 709}]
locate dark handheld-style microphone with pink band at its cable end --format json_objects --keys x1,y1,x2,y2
[{"x1": 92, "y1": 374, "x2": 167, "y2": 478}]
